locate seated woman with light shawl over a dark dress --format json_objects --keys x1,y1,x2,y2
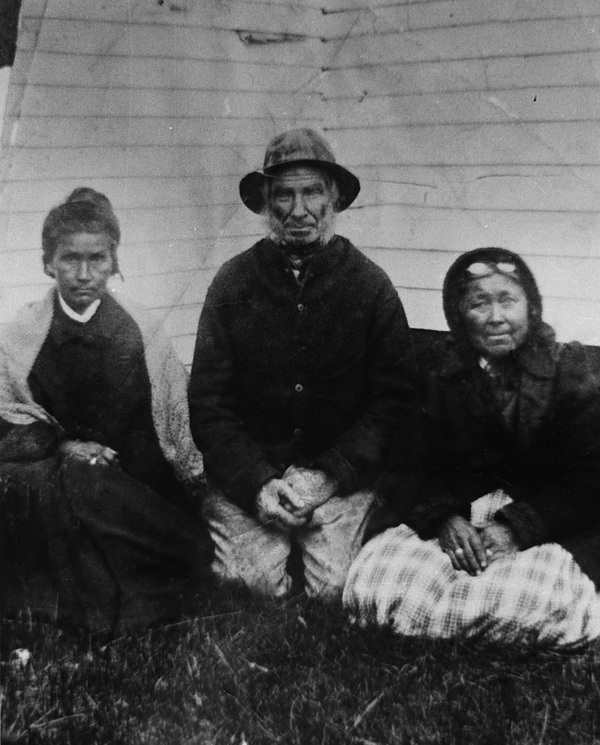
[{"x1": 0, "y1": 188, "x2": 207, "y2": 631}]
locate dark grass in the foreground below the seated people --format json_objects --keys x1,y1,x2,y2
[{"x1": 1, "y1": 591, "x2": 600, "y2": 745}]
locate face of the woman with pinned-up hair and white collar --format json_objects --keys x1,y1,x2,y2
[{"x1": 44, "y1": 233, "x2": 113, "y2": 313}]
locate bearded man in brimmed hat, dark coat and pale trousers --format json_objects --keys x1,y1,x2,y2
[{"x1": 189, "y1": 129, "x2": 413, "y2": 597}]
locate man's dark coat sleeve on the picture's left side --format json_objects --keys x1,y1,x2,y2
[{"x1": 189, "y1": 275, "x2": 281, "y2": 511}]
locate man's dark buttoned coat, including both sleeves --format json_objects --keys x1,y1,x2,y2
[{"x1": 189, "y1": 236, "x2": 413, "y2": 510}]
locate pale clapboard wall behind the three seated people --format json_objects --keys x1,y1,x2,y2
[{"x1": 0, "y1": 0, "x2": 600, "y2": 364}]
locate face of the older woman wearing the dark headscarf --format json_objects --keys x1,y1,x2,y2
[{"x1": 460, "y1": 273, "x2": 529, "y2": 358}]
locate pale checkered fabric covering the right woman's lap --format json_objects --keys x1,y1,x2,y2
[{"x1": 344, "y1": 491, "x2": 600, "y2": 648}]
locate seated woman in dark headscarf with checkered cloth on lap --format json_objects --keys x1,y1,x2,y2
[{"x1": 344, "y1": 248, "x2": 600, "y2": 647}]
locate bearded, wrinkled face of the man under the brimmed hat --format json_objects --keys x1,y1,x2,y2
[{"x1": 267, "y1": 166, "x2": 335, "y2": 247}]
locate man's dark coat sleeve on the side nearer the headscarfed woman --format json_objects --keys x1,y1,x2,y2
[{"x1": 313, "y1": 288, "x2": 415, "y2": 496}]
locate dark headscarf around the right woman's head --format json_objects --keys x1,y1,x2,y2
[{"x1": 443, "y1": 246, "x2": 542, "y2": 341}]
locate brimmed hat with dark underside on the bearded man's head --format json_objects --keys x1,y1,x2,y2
[{"x1": 240, "y1": 129, "x2": 360, "y2": 214}]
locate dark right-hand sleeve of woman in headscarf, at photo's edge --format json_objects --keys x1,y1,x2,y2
[{"x1": 496, "y1": 344, "x2": 600, "y2": 548}]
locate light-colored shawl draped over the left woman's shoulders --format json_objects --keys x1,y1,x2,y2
[{"x1": 0, "y1": 287, "x2": 204, "y2": 482}]
